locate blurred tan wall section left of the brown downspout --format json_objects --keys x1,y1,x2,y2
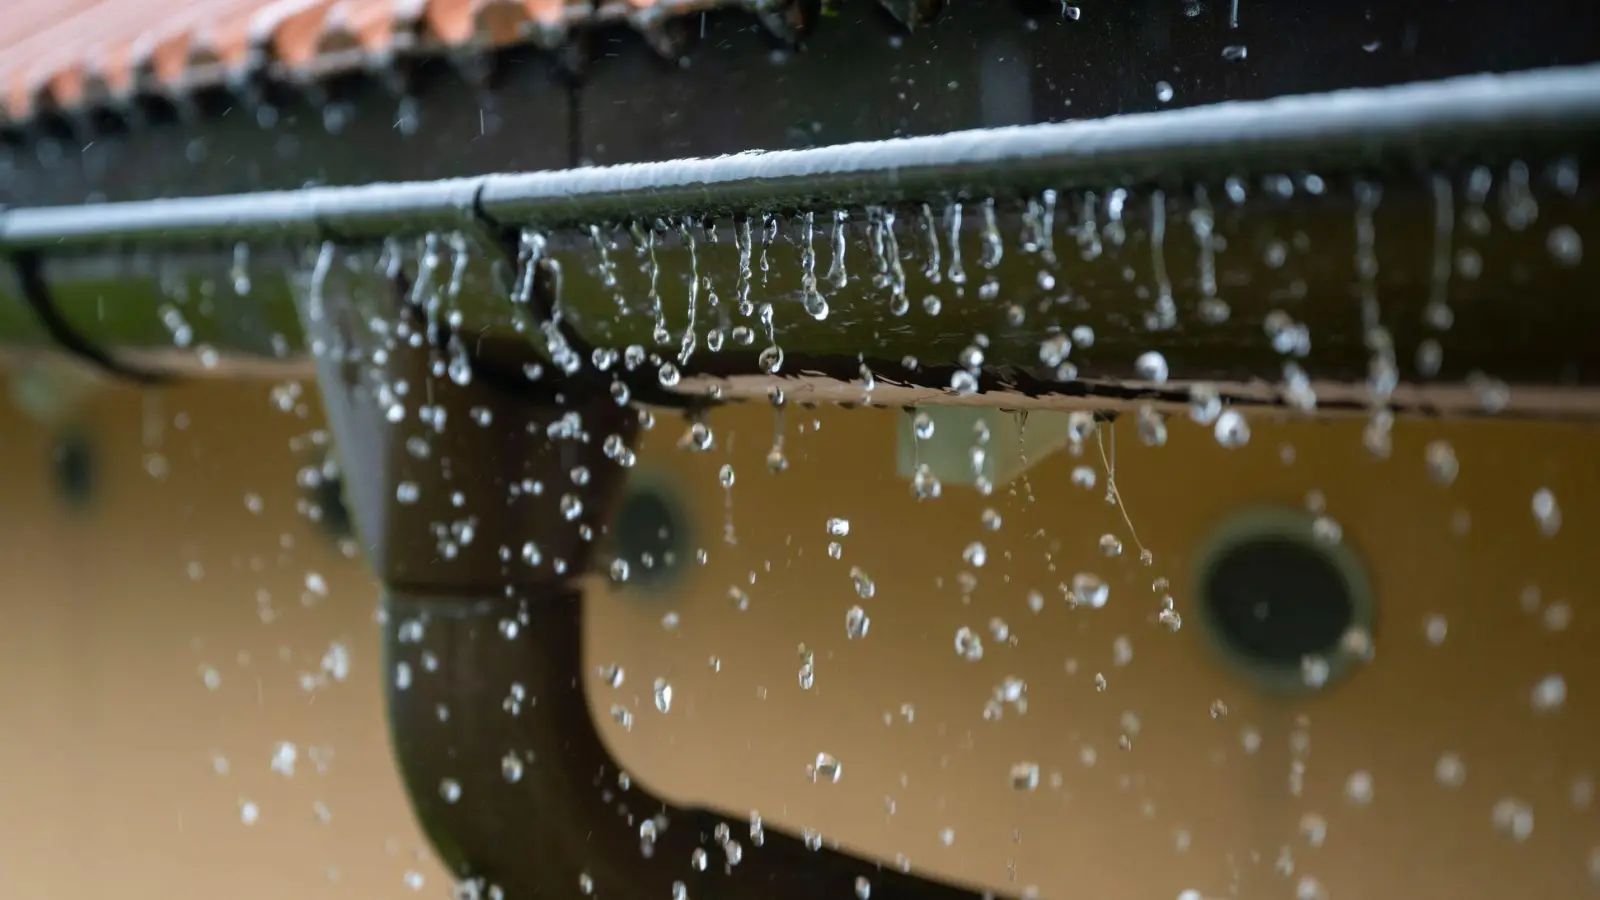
[{"x1": 0, "y1": 368, "x2": 446, "y2": 900}]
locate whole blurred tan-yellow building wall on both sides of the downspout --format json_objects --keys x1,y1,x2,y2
[{"x1": 0, "y1": 366, "x2": 1600, "y2": 900}]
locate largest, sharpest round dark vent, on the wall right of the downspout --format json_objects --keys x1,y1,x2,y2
[{"x1": 1197, "y1": 512, "x2": 1371, "y2": 689}]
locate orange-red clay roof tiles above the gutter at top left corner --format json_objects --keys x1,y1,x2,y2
[{"x1": 0, "y1": 0, "x2": 734, "y2": 125}]
